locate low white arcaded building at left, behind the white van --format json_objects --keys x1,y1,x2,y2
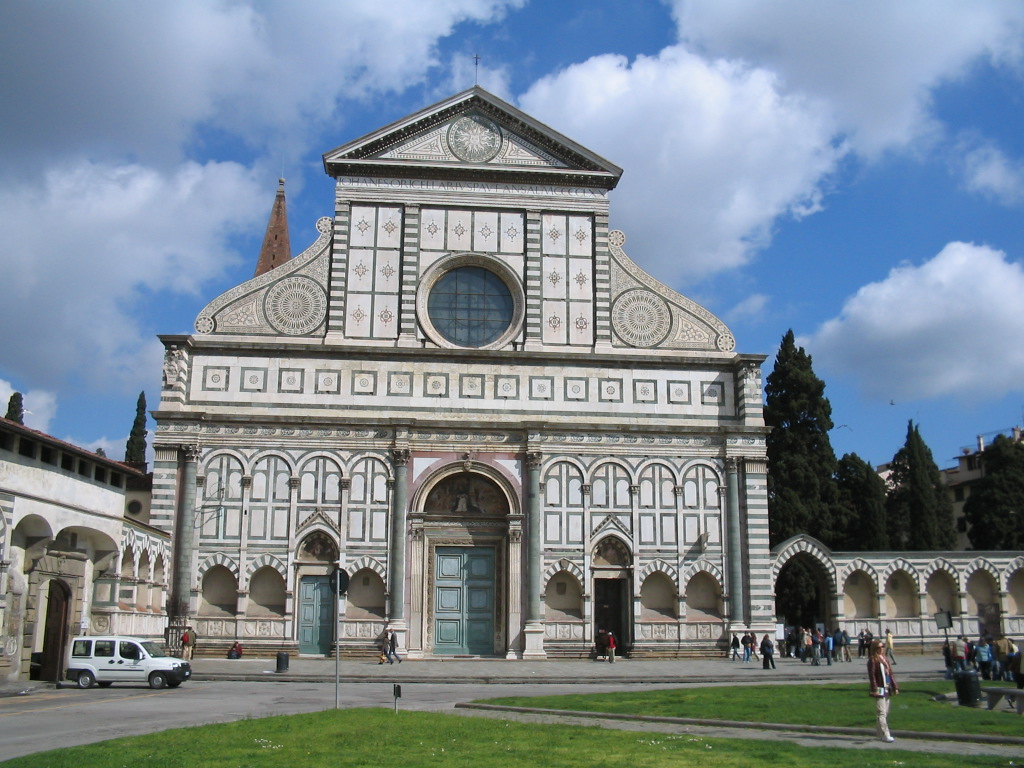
[{"x1": 0, "y1": 419, "x2": 161, "y2": 680}]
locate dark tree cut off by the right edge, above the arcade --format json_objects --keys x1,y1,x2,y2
[{"x1": 964, "y1": 434, "x2": 1024, "y2": 550}]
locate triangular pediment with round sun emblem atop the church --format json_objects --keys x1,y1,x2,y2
[{"x1": 324, "y1": 87, "x2": 622, "y2": 189}]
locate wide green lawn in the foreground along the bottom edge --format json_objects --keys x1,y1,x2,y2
[{"x1": 3, "y1": 708, "x2": 1012, "y2": 768}]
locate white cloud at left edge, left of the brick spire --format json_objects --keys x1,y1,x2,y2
[{"x1": 0, "y1": 162, "x2": 266, "y2": 392}]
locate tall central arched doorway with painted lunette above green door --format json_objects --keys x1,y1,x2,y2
[{"x1": 412, "y1": 470, "x2": 513, "y2": 656}]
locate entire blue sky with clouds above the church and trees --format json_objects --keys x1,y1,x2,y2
[{"x1": 0, "y1": 0, "x2": 1024, "y2": 473}]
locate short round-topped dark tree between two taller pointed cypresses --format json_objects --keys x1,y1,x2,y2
[{"x1": 835, "y1": 454, "x2": 889, "y2": 552}]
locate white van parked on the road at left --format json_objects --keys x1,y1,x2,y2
[{"x1": 67, "y1": 636, "x2": 191, "y2": 688}]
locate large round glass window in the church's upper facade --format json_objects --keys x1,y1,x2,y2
[{"x1": 427, "y1": 266, "x2": 515, "y2": 347}]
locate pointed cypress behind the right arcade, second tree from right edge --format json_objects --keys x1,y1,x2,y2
[{"x1": 886, "y1": 421, "x2": 956, "y2": 551}]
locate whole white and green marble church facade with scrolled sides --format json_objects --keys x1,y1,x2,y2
[{"x1": 153, "y1": 88, "x2": 774, "y2": 658}]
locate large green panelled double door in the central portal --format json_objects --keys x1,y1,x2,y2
[{"x1": 434, "y1": 547, "x2": 495, "y2": 655}]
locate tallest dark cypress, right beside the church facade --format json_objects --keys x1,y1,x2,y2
[{"x1": 764, "y1": 330, "x2": 837, "y2": 547}]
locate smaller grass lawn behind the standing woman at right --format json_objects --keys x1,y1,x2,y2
[{"x1": 481, "y1": 681, "x2": 1024, "y2": 736}]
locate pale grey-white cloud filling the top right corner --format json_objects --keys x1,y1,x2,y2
[{"x1": 672, "y1": 0, "x2": 1024, "y2": 156}]
